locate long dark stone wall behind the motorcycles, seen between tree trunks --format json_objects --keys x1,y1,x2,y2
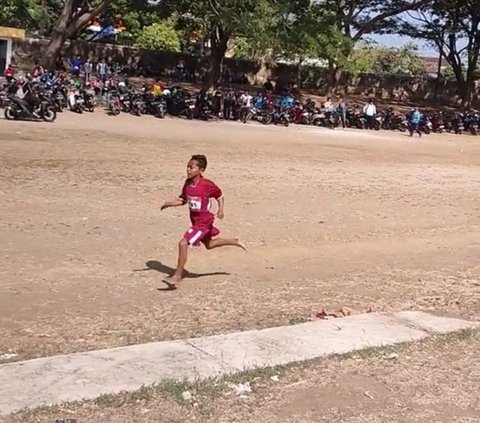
[{"x1": 12, "y1": 38, "x2": 480, "y2": 105}]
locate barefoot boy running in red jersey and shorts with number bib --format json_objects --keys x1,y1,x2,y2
[{"x1": 161, "y1": 155, "x2": 246, "y2": 289}]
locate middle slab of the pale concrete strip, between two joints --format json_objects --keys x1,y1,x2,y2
[{"x1": 189, "y1": 314, "x2": 428, "y2": 371}]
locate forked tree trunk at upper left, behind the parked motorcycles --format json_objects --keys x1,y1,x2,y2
[{"x1": 44, "y1": 0, "x2": 112, "y2": 68}]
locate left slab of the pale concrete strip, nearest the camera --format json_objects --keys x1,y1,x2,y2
[{"x1": 0, "y1": 341, "x2": 235, "y2": 415}]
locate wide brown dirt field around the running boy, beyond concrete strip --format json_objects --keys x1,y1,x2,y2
[{"x1": 0, "y1": 112, "x2": 480, "y2": 364}]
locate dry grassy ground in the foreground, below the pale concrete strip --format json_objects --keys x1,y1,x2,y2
[{"x1": 4, "y1": 331, "x2": 480, "y2": 423}]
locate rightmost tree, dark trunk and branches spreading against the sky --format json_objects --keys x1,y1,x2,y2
[{"x1": 400, "y1": 0, "x2": 480, "y2": 107}]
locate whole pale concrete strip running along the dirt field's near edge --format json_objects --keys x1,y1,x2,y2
[{"x1": 0, "y1": 312, "x2": 480, "y2": 415}]
